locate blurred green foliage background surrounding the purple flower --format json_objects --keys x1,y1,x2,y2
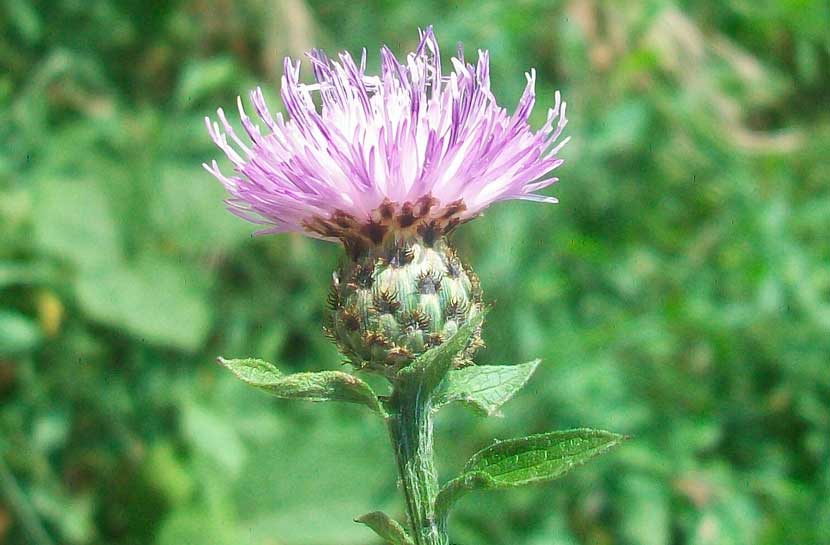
[{"x1": 0, "y1": 0, "x2": 830, "y2": 545}]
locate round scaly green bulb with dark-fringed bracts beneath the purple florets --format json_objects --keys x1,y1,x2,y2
[{"x1": 325, "y1": 235, "x2": 482, "y2": 374}]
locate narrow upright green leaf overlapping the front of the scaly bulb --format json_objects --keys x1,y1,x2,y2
[{"x1": 396, "y1": 308, "x2": 488, "y2": 395}]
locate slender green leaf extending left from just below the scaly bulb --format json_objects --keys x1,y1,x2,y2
[{"x1": 218, "y1": 358, "x2": 384, "y2": 415}]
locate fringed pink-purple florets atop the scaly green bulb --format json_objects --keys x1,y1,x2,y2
[{"x1": 204, "y1": 27, "x2": 568, "y2": 239}]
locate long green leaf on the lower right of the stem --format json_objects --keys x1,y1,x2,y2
[{"x1": 436, "y1": 428, "x2": 625, "y2": 517}]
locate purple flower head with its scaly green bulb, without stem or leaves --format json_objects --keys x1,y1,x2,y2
[{"x1": 205, "y1": 27, "x2": 567, "y2": 370}]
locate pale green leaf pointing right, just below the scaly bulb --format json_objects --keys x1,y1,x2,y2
[{"x1": 433, "y1": 359, "x2": 541, "y2": 416}]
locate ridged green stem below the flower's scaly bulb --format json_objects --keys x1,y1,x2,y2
[{"x1": 387, "y1": 389, "x2": 449, "y2": 545}]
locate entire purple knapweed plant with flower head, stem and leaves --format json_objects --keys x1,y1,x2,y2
[{"x1": 206, "y1": 29, "x2": 624, "y2": 545}]
